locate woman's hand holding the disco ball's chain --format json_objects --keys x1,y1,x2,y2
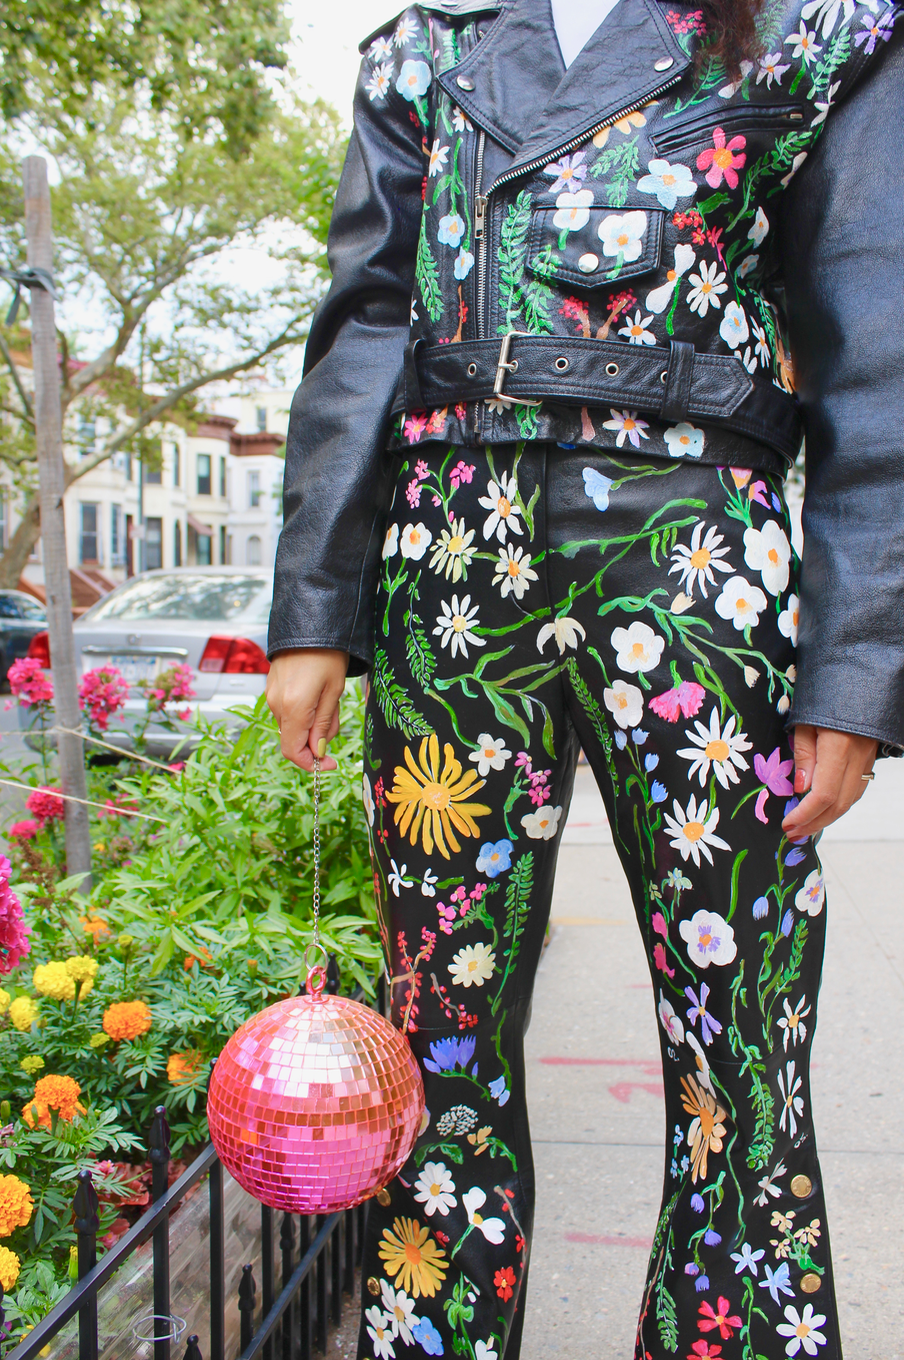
[{"x1": 266, "y1": 647, "x2": 348, "y2": 772}]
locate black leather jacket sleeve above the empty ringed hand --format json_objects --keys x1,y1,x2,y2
[{"x1": 779, "y1": 22, "x2": 904, "y2": 755}]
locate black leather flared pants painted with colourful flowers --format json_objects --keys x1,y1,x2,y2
[{"x1": 359, "y1": 443, "x2": 841, "y2": 1360}]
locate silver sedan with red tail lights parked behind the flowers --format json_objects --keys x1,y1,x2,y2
[{"x1": 19, "y1": 567, "x2": 273, "y2": 756}]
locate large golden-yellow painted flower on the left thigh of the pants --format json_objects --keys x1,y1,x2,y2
[{"x1": 386, "y1": 732, "x2": 491, "y2": 860}]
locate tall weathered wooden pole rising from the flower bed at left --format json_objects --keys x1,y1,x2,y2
[{"x1": 22, "y1": 156, "x2": 91, "y2": 891}]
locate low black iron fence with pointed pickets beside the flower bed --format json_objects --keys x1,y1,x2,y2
[{"x1": 0, "y1": 1106, "x2": 363, "y2": 1360}]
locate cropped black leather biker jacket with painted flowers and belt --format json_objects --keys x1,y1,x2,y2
[{"x1": 271, "y1": 0, "x2": 904, "y2": 748}]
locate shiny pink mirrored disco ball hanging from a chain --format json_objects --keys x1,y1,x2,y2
[{"x1": 207, "y1": 986, "x2": 424, "y2": 1213}]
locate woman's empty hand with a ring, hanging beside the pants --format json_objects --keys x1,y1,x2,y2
[{"x1": 782, "y1": 725, "x2": 878, "y2": 840}]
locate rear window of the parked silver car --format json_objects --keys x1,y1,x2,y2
[{"x1": 90, "y1": 573, "x2": 273, "y2": 623}]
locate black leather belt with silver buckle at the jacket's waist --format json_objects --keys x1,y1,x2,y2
[{"x1": 393, "y1": 332, "x2": 803, "y2": 462}]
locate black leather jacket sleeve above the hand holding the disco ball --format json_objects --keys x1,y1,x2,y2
[{"x1": 268, "y1": 47, "x2": 424, "y2": 675}]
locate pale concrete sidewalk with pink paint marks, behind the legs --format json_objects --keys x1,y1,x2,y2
[{"x1": 522, "y1": 760, "x2": 904, "y2": 1360}]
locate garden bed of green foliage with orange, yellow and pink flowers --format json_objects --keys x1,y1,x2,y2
[{"x1": 0, "y1": 662, "x2": 382, "y2": 1337}]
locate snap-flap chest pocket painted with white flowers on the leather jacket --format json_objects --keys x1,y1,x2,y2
[{"x1": 527, "y1": 202, "x2": 665, "y2": 288}]
